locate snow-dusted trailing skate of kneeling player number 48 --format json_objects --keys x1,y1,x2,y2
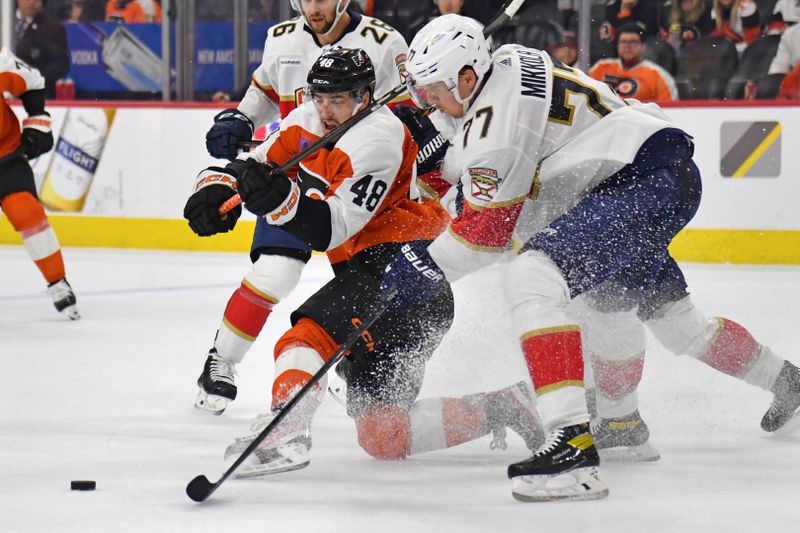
[{"x1": 484, "y1": 381, "x2": 544, "y2": 452}]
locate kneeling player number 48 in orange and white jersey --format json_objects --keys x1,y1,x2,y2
[{"x1": 190, "y1": 47, "x2": 542, "y2": 477}]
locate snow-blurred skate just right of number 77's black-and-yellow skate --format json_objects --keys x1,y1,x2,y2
[{"x1": 591, "y1": 409, "x2": 661, "y2": 463}]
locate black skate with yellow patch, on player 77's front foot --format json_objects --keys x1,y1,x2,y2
[{"x1": 508, "y1": 423, "x2": 608, "y2": 502}]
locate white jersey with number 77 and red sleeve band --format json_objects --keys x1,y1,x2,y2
[{"x1": 429, "y1": 45, "x2": 674, "y2": 282}]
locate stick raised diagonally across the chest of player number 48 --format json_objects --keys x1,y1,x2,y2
[{"x1": 219, "y1": 0, "x2": 525, "y2": 216}]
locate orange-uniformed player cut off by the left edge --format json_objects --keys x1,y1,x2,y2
[{"x1": 0, "y1": 50, "x2": 80, "y2": 320}]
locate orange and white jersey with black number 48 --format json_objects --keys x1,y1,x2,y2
[{"x1": 240, "y1": 102, "x2": 450, "y2": 264}]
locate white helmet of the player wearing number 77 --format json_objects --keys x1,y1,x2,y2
[{"x1": 406, "y1": 14, "x2": 492, "y2": 109}]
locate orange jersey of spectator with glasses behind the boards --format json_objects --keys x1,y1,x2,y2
[{"x1": 589, "y1": 59, "x2": 678, "y2": 102}]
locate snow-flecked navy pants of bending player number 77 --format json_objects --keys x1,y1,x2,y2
[{"x1": 523, "y1": 129, "x2": 702, "y2": 319}]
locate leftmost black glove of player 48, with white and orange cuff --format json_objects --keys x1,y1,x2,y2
[{"x1": 183, "y1": 161, "x2": 242, "y2": 237}]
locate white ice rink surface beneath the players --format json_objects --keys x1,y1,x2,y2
[{"x1": 0, "y1": 247, "x2": 800, "y2": 533}]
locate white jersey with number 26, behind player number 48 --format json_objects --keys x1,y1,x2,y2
[{"x1": 239, "y1": 11, "x2": 411, "y2": 128}]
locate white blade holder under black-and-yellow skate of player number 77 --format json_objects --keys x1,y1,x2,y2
[{"x1": 511, "y1": 467, "x2": 608, "y2": 502}]
